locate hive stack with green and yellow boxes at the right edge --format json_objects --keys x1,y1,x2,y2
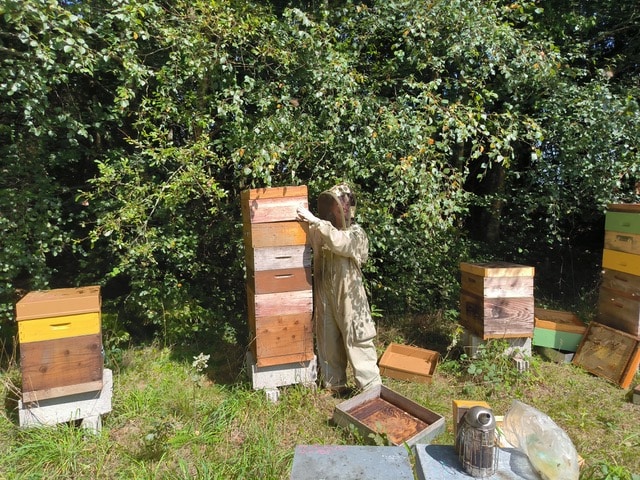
[{"x1": 598, "y1": 204, "x2": 640, "y2": 336}]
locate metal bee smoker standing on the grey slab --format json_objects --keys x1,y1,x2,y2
[{"x1": 456, "y1": 406, "x2": 498, "y2": 478}]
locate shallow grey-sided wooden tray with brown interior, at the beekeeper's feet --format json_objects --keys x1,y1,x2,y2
[{"x1": 333, "y1": 385, "x2": 445, "y2": 446}]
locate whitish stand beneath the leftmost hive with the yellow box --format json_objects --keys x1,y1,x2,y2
[{"x1": 18, "y1": 369, "x2": 113, "y2": 434}]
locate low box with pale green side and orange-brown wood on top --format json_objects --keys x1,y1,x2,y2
[{"x1": 532, "y1": 308, "x2": 587, "y2": 352}]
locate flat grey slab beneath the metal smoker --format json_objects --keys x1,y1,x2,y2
[{"x1": 413, "y1": 444, "x2": 540, "y2": 480}]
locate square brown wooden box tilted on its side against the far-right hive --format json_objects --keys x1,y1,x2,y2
[{"x1": 573, "y1": 322, "x2": 640, "y2": 388}]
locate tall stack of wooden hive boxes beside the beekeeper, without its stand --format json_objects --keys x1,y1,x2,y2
[{"x1": 241, "y1": 186, "x2": 314, "y2": 367}]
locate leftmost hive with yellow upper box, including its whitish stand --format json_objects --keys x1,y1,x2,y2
[{"x1": 16, "y1": 286, "x2": 113, "y2": 433}]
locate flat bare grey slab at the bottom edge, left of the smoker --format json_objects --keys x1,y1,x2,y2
[{"x1": 290, "y1": 445, "x2": 414, "y2": 480}]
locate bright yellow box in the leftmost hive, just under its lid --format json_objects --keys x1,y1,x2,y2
[{"x1": 18, "y1": 312, "x2": 100, "y2": 343}]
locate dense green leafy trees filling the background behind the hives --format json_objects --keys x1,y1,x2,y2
[{"x1": 0, "y1": 0, "x2": 640, "y2": 344}]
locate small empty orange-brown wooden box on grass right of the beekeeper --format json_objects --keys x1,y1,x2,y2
[{"x1": 379, "y1": 343, "x2": 440, "y2": 383}]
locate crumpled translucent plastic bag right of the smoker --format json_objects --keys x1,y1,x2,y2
[{"x1": 502, "y1": 400, "x2": 580, "y2": 480}]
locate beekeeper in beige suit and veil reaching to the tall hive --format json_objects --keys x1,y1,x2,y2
[{"x1": 297, "y1": 184, "x2": 381, "y2": 393}]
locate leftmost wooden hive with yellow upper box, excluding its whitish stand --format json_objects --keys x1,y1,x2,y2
[{"x1": 16, "y1": 286, "x2": 104, "y2": 403}]
